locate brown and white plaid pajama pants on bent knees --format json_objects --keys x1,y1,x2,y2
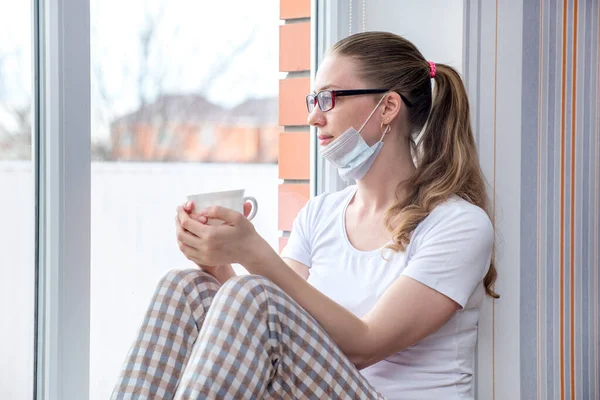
[{"x1": 112, "y1": 269, "x2": 384, "y2": 400}]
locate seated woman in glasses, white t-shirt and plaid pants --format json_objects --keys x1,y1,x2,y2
[{"x1": 113, "y1": 32, "x2": 497, "y2": 400}]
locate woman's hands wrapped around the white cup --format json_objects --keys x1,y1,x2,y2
[{"x1": 176, "y1": 203, "x2": 260, "y2": 268}]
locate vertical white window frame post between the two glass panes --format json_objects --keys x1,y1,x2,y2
[{"x1": 34, "y1": 0, "x2": 91, "y2": 400}]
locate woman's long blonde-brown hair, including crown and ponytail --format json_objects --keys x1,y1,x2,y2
[{"x1": 330, "y1": 32, "x2": 499, "y2": 298}]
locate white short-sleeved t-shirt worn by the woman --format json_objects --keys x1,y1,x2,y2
[{"x1": 282, "y1": 186, "x2": 494, "y2": 400}]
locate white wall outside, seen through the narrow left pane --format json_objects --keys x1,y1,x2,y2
[{"x1": 0, "y1": 162, "x2": 35, "y2": 399}]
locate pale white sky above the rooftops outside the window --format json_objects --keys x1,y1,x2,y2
[{"x1": 0, "y1": 0, "x2": 280, "y2": 141}]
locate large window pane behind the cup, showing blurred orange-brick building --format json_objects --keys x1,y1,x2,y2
[{"x1": 90, "y1": 0, "x2": 279, "y2": 400}]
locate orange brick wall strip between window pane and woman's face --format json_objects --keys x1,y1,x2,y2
[{"x1": 278, "y1": 0, "x2": 310, "y2": 251}]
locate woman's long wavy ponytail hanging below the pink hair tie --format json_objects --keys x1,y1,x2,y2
[{"x1": 385, "y1": 64, "x2": 499, "y2": 298}]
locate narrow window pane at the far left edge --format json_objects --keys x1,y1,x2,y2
[{"x1": 0, "y1": 0, "x2": 35, "y2": 400}]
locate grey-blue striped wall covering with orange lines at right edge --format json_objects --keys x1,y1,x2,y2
[{"x1": 515, "y1": 0, "x2": 600, "y2": 400}]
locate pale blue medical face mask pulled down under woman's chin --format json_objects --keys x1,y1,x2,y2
[{"x1": 320, "y1": 95, "x2": 387, "y2": 182}]
